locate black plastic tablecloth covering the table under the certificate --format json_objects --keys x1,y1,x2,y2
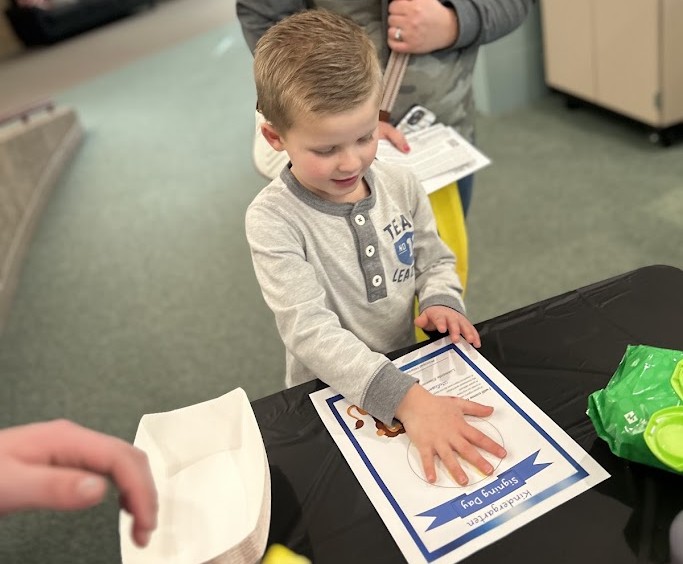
[{"x1": 252, "y1": 266, "x2": 683, "y2": 564}]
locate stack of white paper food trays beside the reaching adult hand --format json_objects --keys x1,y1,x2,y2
[{"x1": 119, "y1": 388, "x2": 270, "y2": 564}]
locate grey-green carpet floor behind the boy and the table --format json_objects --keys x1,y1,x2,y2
[{"x1": 0, "y1": 15, "x2": 683, "y2": 564}]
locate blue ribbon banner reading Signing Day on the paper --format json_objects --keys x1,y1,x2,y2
[{"x1": 418, "y1": 450, "x2": 552, "y2": 531}]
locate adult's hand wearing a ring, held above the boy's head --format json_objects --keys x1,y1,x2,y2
[{"x1": 387, "y1": 0, "x2": 460, "y2": 54}]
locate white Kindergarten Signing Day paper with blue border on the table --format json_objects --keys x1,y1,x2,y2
[{"x1": 311, "y1": 339, "x2": 609, "y2": 563}]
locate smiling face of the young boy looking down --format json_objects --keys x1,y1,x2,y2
[{"x1": 262, "y1": 96, "x2": 379, "y2": 202}]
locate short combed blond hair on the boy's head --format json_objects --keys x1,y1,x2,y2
[{"x1": 254, "y1": 10, "x2": 382, "y2": 134}]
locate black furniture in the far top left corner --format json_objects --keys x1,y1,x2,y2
[{"x1": 5, "y1": 0, "x2": 155, "y2": 46}]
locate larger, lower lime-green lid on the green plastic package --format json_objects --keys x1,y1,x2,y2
[{"x1": 643, "y1": 406, "x2": 683, "y2": 472}]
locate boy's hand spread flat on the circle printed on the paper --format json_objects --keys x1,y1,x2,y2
[{"x1": 396, "y1": 384, "x2": 507, "y2": 485}]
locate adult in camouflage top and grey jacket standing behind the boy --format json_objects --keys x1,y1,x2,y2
[{"x1": 237, "y1": 0, "x2": 534, "y2": 215}]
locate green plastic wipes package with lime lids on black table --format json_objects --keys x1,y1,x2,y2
[{"x1": 587, "y1": 345, "x2": 683, "y2": 473}]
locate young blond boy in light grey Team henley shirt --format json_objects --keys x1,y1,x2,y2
[{"x1": 246, "y1": 10, "x2": 505, "y2": 484}]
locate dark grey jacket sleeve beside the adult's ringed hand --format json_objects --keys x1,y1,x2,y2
[{"x1": 444, "y1": 0, "x2": 535, "y2": 49}]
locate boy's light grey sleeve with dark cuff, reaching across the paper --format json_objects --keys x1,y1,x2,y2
[{"x1": 246, "y1": 203, "x2": 416, "y2": 425}]
